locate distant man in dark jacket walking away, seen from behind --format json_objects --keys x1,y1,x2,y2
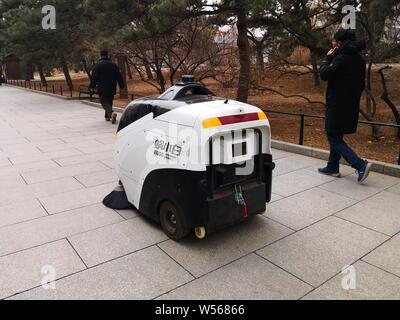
[{"x1": 90, "y1": 50, "x2": 125, "y2": 124}]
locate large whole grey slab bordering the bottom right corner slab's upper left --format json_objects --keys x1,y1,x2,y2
[{"x1": 259, "y1": 217, "x2": 388, "y2": 286}]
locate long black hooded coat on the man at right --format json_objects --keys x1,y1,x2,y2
[{"x1": 320, "y1": 41, "x2": 366, "y2": 134}]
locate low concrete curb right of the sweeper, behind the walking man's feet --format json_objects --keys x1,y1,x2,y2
[{"x1": 272, "y1": 140, "x2": 400, "y2": 178}]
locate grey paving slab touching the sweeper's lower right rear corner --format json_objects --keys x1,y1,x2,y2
[{"x1": 265, "y1": 188, "x2": 357, "y2": 230}]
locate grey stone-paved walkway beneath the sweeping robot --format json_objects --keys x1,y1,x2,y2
[{"x1": 0, "y1": 86, "x2": 400, "y2": 299}]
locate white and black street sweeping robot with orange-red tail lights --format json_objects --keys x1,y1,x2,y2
[{"x1": 104, "y1": 77, "x2": 275, "y2": 240}]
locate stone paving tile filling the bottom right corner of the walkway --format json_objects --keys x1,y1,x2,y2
[{"x1": 304, "y1": 261, "x2": 400, "y2": 300}]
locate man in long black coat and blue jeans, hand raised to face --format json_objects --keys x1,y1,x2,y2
[{"x1": 319, "y1": 29, "x2": 372, "y2": 183}]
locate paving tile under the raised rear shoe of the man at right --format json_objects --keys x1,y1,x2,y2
[{"x1": 321, "y1": 172, "x2": 400, "y2": 200}]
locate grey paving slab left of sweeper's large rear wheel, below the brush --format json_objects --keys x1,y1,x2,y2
[{"x1": 69, "y1": 218, "x2": 167, "y2": 267}]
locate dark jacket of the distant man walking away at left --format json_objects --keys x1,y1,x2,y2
[{"x1": 90, "y1": 59, "x2": 125, "y2": 97}]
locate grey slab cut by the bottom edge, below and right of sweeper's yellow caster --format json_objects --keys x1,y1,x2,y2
[{"x1": 160, "y1": 254, "x2": 312, "y2": 300}]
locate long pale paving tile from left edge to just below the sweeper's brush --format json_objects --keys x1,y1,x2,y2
[{"x1": 0, "y1": 205, "x2": 123, "y2": 256}]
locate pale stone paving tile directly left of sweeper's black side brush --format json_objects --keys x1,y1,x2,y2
[{"x1": 39, "y1": 183, "x2": 115, "y2": 214}]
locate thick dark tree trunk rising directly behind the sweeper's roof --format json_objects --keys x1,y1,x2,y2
[{"x1": 235, "y1": 0, "x2": 251, "y2": 102}]
